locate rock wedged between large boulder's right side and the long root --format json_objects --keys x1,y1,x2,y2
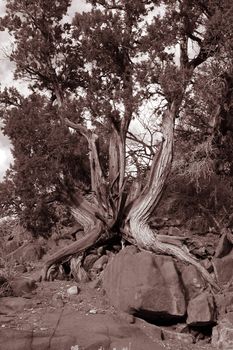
[{"x1": 181, "y1": 265, "x2": 206, "y2": 300}]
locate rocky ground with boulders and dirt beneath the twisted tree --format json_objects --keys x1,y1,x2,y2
[{"x1": 0, "y1": 220, "x2": 233, "y2": 350}]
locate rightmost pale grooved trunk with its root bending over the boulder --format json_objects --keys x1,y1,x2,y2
[{"x1": 125, "y1": 104, "x2": 219, "y2": 290}]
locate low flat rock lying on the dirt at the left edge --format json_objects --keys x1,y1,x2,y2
[{"x1": 0, "y1": 297, "x2": 32, "y2": 315}]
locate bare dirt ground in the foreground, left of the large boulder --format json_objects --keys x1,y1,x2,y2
[{"x1": 0, "y1": 266, "x2": 217, "y2": 350}]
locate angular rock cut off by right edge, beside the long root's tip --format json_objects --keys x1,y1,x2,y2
[{"x1": 212, "y1": 254, "x2": 233, "y2": 285}]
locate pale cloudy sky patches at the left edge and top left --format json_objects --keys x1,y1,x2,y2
[{"x1": 0, "y1": 0, "x2": 89, "y2": 181}]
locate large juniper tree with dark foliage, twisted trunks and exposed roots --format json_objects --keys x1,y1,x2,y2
[{"x1": 2, "y1": 0, "x2": 232, "y2": 285}]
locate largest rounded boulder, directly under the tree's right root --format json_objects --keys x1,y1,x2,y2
[{"x1": 103, "y1": 247, "x2": 186, "y2": 320}]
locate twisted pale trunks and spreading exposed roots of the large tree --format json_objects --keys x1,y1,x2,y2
[{"x1": 42, "y1": 104, "x2": 218, "y2": 290}]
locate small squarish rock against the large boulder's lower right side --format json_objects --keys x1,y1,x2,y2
[{"x1": 187, "y1": 292, "x2": 217, "y2": 326}]
